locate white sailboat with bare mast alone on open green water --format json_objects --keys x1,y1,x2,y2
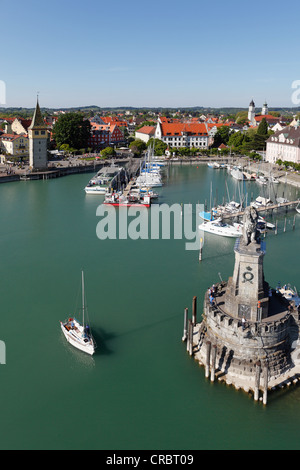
[{"x1": 60, "y1": 271, "x2": 96, "y2": 355}]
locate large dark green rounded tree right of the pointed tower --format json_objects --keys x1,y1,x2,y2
[{"x1": 53, "y1": 112, "x2": 91, "y2": 150}]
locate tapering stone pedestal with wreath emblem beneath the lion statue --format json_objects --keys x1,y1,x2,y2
[{"x1": 224, "y1": 240, "x2": 269, "y2": 322}]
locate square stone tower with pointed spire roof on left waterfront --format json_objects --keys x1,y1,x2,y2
[{"x1": 28, "y1": 100, "x2": 48, "y2": 170}]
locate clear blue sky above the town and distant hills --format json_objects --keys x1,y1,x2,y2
[{"x1": 0, "y1": 0, "x2": 300, "y2": 108}]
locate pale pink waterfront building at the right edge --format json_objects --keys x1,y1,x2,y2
[{"x1": 266, "y1": 122, "x2": 300, "y2": 163}]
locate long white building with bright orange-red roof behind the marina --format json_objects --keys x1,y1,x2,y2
[{"x1": 154, "y1": 118, "x2": 209, "y2": 149}]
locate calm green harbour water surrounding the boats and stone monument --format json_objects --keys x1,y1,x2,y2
[{"x1": 0, "y1": 165, "x2": 300, "y2": 450}]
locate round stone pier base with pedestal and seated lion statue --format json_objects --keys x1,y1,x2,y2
[{"x1": 183, "y1": 207, "x2": 300, "y2": 403}]
